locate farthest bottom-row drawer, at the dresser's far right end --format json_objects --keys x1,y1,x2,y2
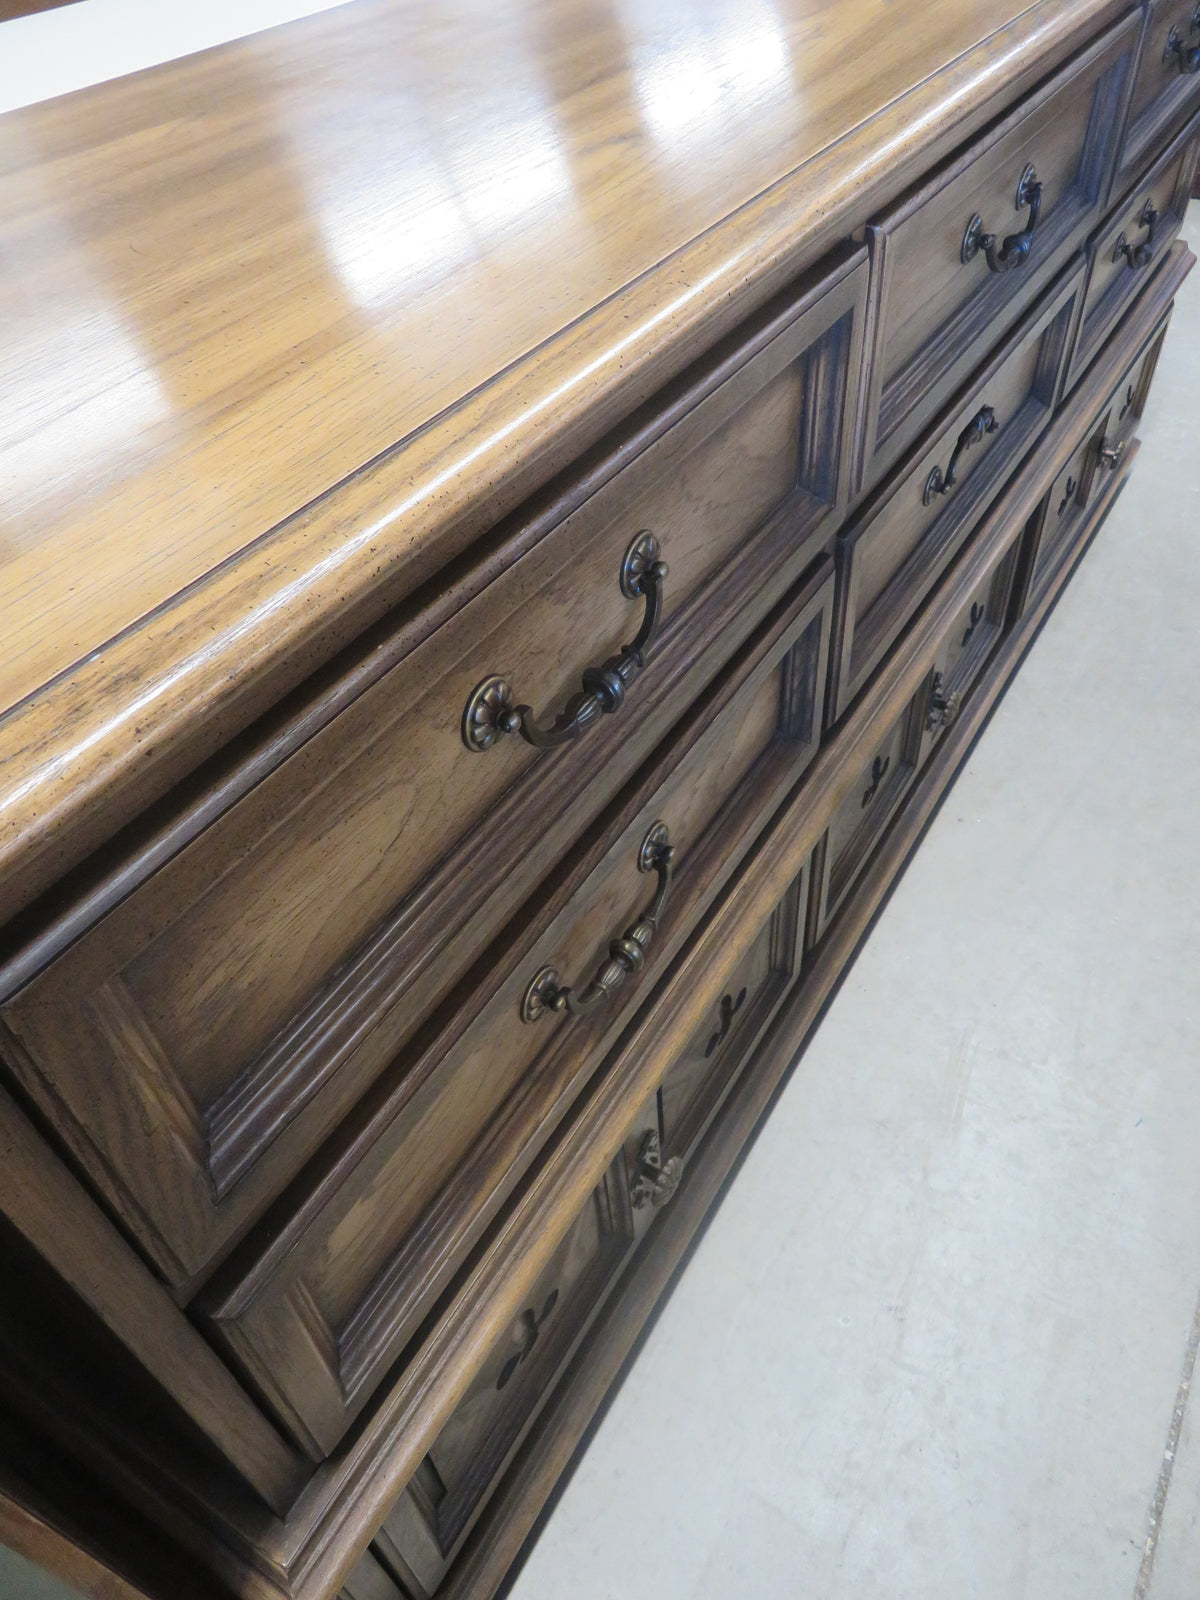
[{"x1": 1022, "y1": 310, "x2": 1170, "y2": 610}]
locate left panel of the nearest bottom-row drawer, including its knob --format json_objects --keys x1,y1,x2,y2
[{"x1": 374, "y1": 1101, "x2": 659, "y2": 1597}]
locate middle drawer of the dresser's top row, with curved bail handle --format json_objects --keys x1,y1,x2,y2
[{"x1": 856, "y1": 18, "x2": 1138, "y2": 488}]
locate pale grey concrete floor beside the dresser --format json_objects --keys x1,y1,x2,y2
[{"x1": 0, "y1": 216, "x2": 1200, "y2": 1600}]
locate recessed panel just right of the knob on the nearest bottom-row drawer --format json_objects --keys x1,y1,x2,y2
[{"x1": 658, "y1": 867, "x2": 810, "y2": 1162}]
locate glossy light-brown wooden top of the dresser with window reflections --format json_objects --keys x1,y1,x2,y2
[{"x1": 0, "y1": 0, "x2": 1125, "y2": 904}]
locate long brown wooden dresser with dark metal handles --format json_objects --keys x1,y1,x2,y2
[{"x1": 0, "y1": 0, "x2": 1200, "y2": 1600}]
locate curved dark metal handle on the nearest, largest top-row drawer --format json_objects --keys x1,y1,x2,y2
[{"x1": 462, "y1": 531, "x2": 667, "y2": 750}]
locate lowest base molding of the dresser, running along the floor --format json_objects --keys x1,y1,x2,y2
[{"x1": 437, "y1": 443, "x2": 1138, "y2": 1600}]
